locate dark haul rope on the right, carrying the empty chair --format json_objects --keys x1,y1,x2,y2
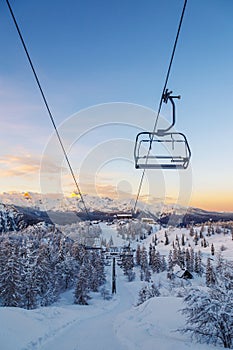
[{"x1": 133, "y1": 0, "x2": 188, "y2": 213}]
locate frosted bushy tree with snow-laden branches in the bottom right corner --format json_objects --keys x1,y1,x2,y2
[{"x1": 181, "y1": 283, "x2": 233, "y2": 348}]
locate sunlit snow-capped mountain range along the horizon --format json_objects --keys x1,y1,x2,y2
[{"x1": 0, "y1": 192, "x2": 233, "y2": 227}]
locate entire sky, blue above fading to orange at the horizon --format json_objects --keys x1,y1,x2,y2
[{"x1": 0, "y1": 0, "x2": 233, "y2": 211}]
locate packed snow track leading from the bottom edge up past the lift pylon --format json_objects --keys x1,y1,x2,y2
[{"x1": 33, "y1": 269, "x2": 133, "y2": 350}]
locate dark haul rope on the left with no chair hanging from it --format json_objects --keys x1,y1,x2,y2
[{"x1": 6, "y1": 0, "x2": 90, "y2": 220}]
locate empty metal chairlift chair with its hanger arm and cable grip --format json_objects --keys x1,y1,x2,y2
[{"x1": 134, "y1": 90, "x2": 191, "y2": 169}]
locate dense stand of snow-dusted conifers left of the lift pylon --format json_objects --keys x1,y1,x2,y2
[{"x1": 0, "y1": 223, "x2": 105, "y2": 309}]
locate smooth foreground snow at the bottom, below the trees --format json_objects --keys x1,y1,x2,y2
[{"x1": 0, "y1": 267, "x2": 223, "y2": 350}]
